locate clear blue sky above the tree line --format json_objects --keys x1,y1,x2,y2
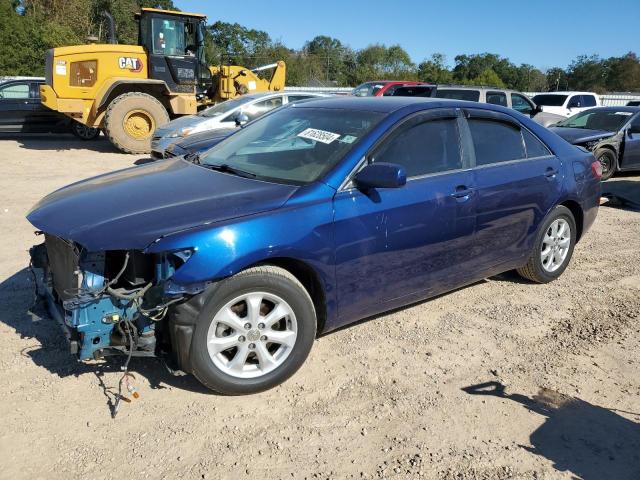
[{"x1": 174, "y1": 0, "x2": 640, "y2": 69}]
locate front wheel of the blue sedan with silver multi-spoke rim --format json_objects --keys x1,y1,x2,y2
[{"x1": 190, "y1": 266, "x2": 317, "y2": 395}]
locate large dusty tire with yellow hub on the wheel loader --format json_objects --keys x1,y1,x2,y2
[{"x1": 104, "y1": 92, "x2": 169, "y2": 153}]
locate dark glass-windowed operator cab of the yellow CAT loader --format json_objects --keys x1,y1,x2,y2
[{"x1": 137, "y1": 8, "x2": 211, "y2": 93}]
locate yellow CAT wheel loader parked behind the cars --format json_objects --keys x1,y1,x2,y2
[{"x1": 40, "y1": 8, "x2": 286, "y2": 153}]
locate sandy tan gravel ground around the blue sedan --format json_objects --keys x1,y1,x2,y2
[{"x1": 0, "y1": 137, "x2": 640, "y2": 480}]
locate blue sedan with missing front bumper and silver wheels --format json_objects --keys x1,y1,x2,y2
[{"x1": 28, "y1": 97, "x2": 602, "y2": 394}]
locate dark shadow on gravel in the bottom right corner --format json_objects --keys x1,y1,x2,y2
[{"x1": 462, "y1": 381, "x2": 640, "y2": 480}]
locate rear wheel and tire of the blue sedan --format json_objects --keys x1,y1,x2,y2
[{"x1": 517, "y1": 205, "x2": 576, "y2": 283}]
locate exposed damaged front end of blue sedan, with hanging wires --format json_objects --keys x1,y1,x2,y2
[{"x1": 30, "y1": 232, "x2": 193, "y2": 360}]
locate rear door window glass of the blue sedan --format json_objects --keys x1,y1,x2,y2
[{"x1": 468, "y1": 118, "x2": 525, "y2": 166}]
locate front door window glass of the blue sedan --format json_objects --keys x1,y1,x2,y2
[{"x1": 373, "y1": 119, "x2": 462, "y2": 177}]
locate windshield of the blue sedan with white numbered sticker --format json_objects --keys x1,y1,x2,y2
[{"x1": 200, "y1": 106, "x2": 383, "y2": 184}]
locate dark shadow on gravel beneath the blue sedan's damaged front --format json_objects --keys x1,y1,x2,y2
[{"x1": 0, "y1": 268, "x2": 211, "y2": 408}]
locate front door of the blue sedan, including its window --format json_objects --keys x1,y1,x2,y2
[{"x1": 334, "y1": 109, "x2": 475, "y2": 319}]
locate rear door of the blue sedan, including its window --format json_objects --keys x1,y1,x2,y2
[{"x1": 465, "y1": 109, "x2": 562, "y2": 278}]
